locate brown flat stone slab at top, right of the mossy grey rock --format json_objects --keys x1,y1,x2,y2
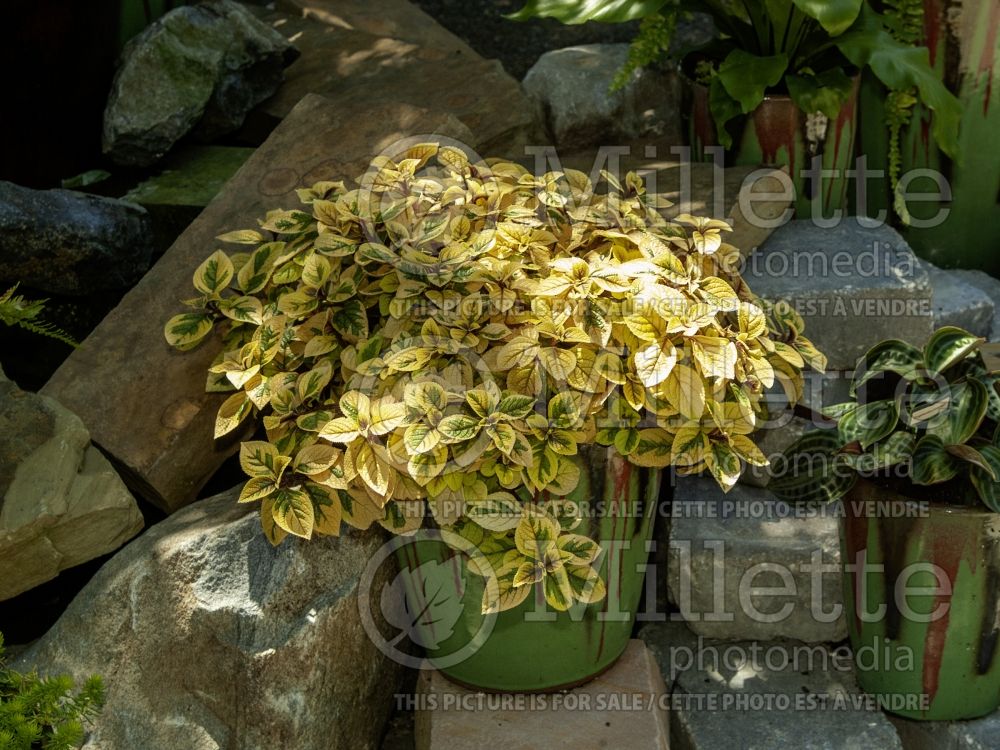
[{"x1": 257, "y1": 0, "x2": 541, "y2": 157}]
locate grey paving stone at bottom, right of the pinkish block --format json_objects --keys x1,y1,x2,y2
[{"x1": 639, "y1": 622, "x2": 904, "y2": 750}]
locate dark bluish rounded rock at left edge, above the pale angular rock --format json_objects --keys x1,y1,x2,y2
[{"x1": 0, "y1": 182, "x2": 153, "y2": 295}]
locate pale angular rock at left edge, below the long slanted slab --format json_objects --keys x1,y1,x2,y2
[{"x1": 0, "y1": 373, "x2": 143, "y2": 600}]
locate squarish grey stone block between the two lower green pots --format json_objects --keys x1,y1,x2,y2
[{"x1": 667, "y1": 477, "x2": 847, "y2": 643}]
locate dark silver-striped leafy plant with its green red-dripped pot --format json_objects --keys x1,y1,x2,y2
[{"x1": 768, "y1": 327, "x2": 1000, "y2": 719}]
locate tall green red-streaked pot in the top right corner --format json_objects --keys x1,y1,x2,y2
[{"x1": 858, "y1": 0, "x2": 1000, "y2": 276}]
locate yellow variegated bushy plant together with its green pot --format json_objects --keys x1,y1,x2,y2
[{"x1": 165, "y1": 143, "x2": 825, "y2": 690}]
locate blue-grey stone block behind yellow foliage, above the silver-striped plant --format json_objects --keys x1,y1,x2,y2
[{"x1": 744, "y1": 218, "x2": 933, "y2": 370}]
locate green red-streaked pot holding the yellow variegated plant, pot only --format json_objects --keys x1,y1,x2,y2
[{"x1": 397, "y1": 446, "x2": 660, "y2": 692}]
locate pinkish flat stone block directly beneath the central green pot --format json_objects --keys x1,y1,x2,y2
[{"x1": 415, "y1": 640, "x2": 669, "y2": 750}]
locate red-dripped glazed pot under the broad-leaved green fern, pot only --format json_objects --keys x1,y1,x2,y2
[{"x1": 688, "y1": 78, "x2": 858, "y2": 219}]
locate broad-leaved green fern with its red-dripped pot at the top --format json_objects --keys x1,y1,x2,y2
[{"x1": 513, "y1": 0, "x2": 960, "y2": 218}]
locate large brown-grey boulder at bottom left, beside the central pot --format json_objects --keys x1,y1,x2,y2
[{"x1": 15, "y1": 488, "x2": 400, "y2": 750}]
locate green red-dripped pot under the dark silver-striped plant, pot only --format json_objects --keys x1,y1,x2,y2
[{"x1": 842, "y1": 481, "x2": 1000, "y2": 720}]
